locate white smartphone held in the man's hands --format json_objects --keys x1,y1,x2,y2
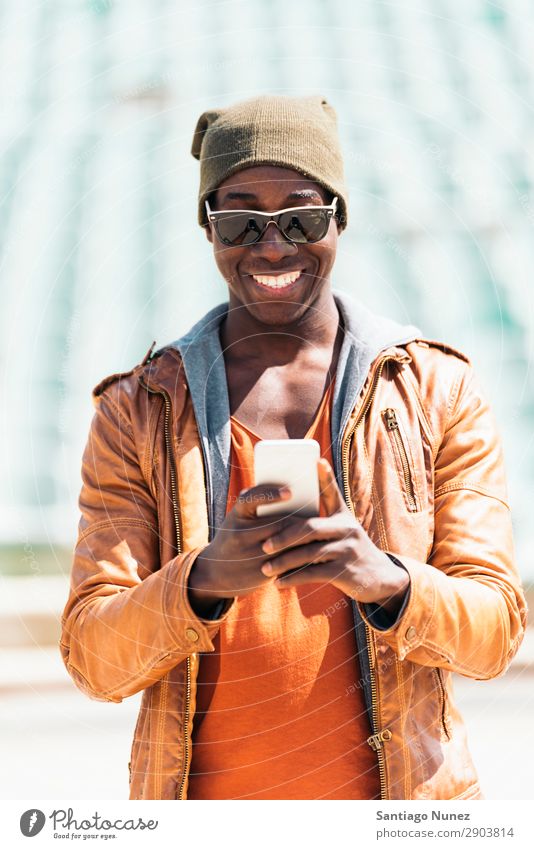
[{"x1": 254, "y1": 439, "x2": 321, "y2": 516}]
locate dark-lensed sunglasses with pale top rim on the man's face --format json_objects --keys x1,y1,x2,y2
[{"x1": 205, "y1": 197, "x2": 337, "y2": 247}]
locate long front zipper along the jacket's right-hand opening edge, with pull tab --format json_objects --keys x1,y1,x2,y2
[{"x1": 341, "y1": 354, "x2": 410, "y2": 799}]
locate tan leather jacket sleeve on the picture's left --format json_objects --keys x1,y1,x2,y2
[{"x1": 59, "y1": 389, "x2": 231, "y2": 702}]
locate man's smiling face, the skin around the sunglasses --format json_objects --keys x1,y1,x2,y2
[{"x1": 206, "y1": 165, "x2": 338, "y2": 325}]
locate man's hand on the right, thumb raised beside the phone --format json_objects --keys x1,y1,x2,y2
[{"x1": 261, "y1": 459, "x2": 410, "y2": 614}]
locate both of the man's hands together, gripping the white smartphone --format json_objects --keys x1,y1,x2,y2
[{"x1": 188, "y1": 459, "x2": 410, "y2": 616}]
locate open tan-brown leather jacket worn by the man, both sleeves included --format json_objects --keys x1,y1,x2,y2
[{"x1": 60, "y1": 294, "x2": 527, "y2": 799}]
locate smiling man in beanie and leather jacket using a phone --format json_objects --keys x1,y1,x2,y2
[{"x1": 61, "y1": 97, "x2": 526, "y2": 799}]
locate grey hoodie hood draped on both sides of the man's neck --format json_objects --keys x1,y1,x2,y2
[{"x1": 165, "y1": 290, "x2": 422, "y2": 540}]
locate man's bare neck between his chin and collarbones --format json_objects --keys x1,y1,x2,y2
[{"x1": 220, "y1": 287, "x2": 340, "y2": 365}]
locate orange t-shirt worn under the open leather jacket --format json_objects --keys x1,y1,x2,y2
[{"x1": 187, "y1": 383, "x2": 380, "y2": 799}]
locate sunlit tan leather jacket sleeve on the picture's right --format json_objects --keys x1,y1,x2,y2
[{"x1": 358, "y1": 363, "x2": 527, "y2": 679}]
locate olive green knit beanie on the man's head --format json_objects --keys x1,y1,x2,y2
[{"x1": 191, "y1": 95, "x2": 347, "y2": 229}]
